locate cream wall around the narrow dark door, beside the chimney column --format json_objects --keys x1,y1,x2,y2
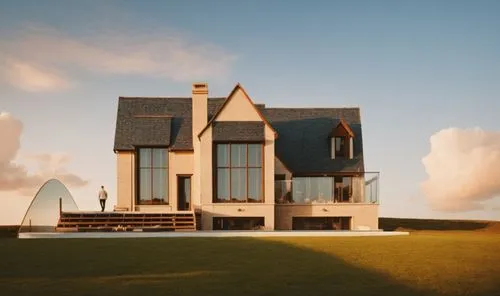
[{"x1": 168, "y1": 151, "x2": 199, "y2": 211}]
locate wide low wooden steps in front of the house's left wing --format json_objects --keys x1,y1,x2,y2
[{"x1": 56, "y1": 212, "x2": 197, "y2": 232}]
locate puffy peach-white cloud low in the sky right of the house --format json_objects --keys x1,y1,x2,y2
[{"x1": 421, "y1": 128, "x2": 500, "y2": 212}]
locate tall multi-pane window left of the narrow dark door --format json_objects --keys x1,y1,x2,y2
[{"x1": 137, "y1": 148, "x2": 168, "y2": 205}]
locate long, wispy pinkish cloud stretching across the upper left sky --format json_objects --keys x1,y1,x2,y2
[{"x1": 0, "y1": 27, "x2": 236, "y2": 92}]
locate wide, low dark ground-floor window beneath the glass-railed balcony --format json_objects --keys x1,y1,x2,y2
[{"x1": 292, "y1": 217, "x2": 351, "y2": 230}]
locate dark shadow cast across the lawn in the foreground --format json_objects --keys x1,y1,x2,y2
[{"x1": 0, "y1": 238, "x2": 458, "y2": 296}]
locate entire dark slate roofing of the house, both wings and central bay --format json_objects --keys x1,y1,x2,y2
[{"x1": 114, "y1": 97, "x2": 364, "y2": 174}]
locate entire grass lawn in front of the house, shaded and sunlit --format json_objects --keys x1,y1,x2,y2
[{"x1": 0, "y1": 231, "x2": 500, "y2": 296}]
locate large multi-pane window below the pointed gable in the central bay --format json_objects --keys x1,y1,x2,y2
[{"x1": 214, "y1": 144, "x2": 264, "y2": 202}]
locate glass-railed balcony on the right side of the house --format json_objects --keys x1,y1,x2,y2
[{"x1": 274, "y1": 172, "x2": 379, "y2": 204}]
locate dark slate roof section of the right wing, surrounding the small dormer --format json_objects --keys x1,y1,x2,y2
[{"x1": 261, "y1": 108, "x2": 364, "y2": 174}]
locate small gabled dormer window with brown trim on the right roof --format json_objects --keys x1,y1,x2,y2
[{"x1": 330, "y1": 119, "x2": 354, "y2": 159}]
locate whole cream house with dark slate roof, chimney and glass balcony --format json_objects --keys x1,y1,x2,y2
[{"x1": 114, "y1": 83, "x2": 378, "y2": 230}]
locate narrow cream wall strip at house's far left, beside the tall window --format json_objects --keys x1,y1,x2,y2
[{"x1": 116, "y1": 151, "x2": 135, "y2": 211}]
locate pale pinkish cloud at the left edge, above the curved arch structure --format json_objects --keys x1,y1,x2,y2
[{"x1": 0, "y1": 112, "x2": 88, "y2": 196}]
